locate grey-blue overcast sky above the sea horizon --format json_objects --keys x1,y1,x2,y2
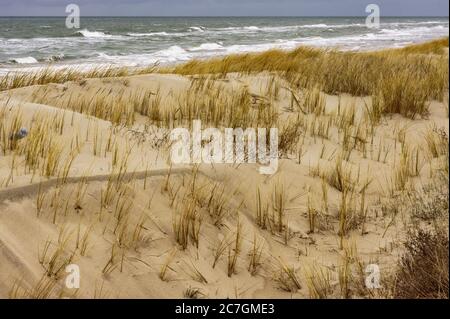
[{"x1": 0, "y1": 0, "x2": 449, "y2": 16}]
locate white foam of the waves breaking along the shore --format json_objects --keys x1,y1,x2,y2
[{"x1": 0, "y1": 23, "x2": 449, "y2": 75}]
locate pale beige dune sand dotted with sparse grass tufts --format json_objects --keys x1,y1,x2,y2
[{"x1": 0, "y1": 67, "x2": 449, "y2": 298}]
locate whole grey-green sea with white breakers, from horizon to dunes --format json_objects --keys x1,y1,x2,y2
[{"x1": 0, "y1": 17, "x2": 449, "y2": 74}]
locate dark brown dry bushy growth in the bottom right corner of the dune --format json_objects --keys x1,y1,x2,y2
[{"x1": 392, "y1": 173, "x2": 449, "y2": 299}]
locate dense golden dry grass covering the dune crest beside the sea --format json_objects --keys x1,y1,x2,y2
[{"x1": 168, "y1": 38, "x2": 448, "y2": 118}]
